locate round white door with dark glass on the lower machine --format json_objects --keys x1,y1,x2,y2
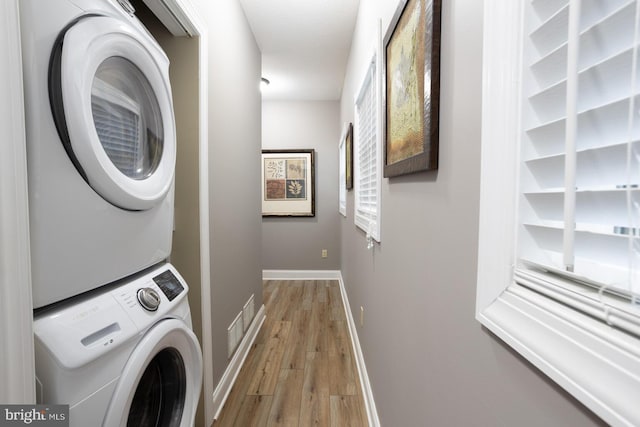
[{"x1": 103, "y1": 319, "x2": 202, "y2": 427}]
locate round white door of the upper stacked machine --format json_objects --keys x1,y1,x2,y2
[{"x1": 49, "y1": 15, "x2": 176, "y2": 210}]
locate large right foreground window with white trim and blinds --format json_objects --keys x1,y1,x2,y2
[{"x1": 477, "y1": 0, "x2": 640, "y2": 425}]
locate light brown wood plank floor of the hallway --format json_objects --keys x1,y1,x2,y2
[{"x1": 213, "y1": 280, "x2": 368, "y2": 427}]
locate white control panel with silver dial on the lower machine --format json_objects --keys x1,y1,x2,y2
[{"x1": 34, "y1": 263, "x2": 190, "y2": 369}]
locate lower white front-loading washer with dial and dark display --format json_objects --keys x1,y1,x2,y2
[{"x1": 34, "y1": 264, "x2": 202, "y2": 427}]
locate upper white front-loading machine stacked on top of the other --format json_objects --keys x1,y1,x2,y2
[{"x1": 20, "y1": 0, "x2": 176, "y2": 308}]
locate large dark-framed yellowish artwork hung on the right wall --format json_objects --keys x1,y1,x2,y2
[{"x1": 383, "y1": 0, "x2": 442, "y2": 177}]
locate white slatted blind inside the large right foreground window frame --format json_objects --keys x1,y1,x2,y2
[{"x1": 516, "y1": 0, "x2": 640, "y2": 320}]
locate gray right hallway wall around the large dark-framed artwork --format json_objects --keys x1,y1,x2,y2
[{"x1": 341, "y1": 0, "x2": 598, "y2": 427}]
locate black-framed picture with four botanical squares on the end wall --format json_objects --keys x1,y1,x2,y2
[{"x1": 262, "y1": 150, "x2": 316, "y2": 216}]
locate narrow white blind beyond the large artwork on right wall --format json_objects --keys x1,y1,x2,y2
[{"x1": 354, "y1": 56, "x2": 380, "y2": 247}]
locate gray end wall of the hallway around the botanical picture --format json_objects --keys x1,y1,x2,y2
[{"x1": 262, "y1": 101, "x2": 342, "y2": 270}]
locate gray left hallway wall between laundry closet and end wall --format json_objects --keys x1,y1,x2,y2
[{"x1": 198, "y1": 0, "x2": 262, "y2": 384}]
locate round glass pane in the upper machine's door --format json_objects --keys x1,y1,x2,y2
[{"x1": 91, "y1": 56, "x2": 164, "y2": 180}]
